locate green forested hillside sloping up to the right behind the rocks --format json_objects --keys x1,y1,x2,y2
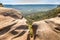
[{"x1": 25, "y1": 5, "x2": 60, "y2": 22}]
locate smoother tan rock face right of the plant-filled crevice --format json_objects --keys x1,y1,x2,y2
[{"x1": 33, "y1": 16, "x2": 60, "y2": 40}]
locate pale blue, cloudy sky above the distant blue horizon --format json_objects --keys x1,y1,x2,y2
[{"x1": 0, "y1": 0, "x2": 60, "y2": 4}]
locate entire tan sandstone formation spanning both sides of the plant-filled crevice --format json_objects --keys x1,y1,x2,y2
[{"x1": 0, "y1": 7, "x2": 60, "y2": 40}]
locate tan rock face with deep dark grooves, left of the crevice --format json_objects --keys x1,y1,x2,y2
[{"x1": 0, "y1": 7, "x2": 29, "y2": 40}]
